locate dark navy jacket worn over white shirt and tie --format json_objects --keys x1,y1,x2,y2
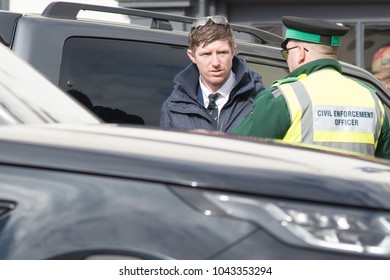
[{"x1": 160, "y1": 56, "x2": 264, "y2": 133}]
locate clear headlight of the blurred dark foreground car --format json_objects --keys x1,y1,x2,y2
[{"x1": 171, "y1": 188, "x2": 390, "y2": 257}]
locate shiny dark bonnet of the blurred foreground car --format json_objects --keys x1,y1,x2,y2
[{"x1": 0, "y1": 124, "x2": 390, "y2": 209}]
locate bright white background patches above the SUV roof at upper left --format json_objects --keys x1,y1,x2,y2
[{"x1": 9, "y1": 0, "x2": 118, "y2": 13}]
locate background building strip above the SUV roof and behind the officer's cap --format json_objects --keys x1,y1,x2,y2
[{"x1": 0, "y1": 0, "x2": 390, "y2": 71}]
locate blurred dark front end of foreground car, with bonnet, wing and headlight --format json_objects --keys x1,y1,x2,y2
[{"x1": 0, "y1": 124, "x2": 390, "y2": 260}]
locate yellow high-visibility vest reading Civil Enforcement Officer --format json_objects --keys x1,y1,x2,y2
[{"x1": 274, "y1": 69, "x2": 385, "y2": 155}]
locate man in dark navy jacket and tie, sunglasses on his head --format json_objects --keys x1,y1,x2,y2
[{"x1": 160, "y1": 16, "x2": 264, "y2": 132}]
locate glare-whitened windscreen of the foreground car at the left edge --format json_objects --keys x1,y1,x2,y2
[{"x1": 0, "y1": 39, "x2": 101, "y2": 125}]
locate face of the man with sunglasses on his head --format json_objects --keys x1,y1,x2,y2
[{"x1": 187, "y1": 40, "x2": 235, "y2": 92}]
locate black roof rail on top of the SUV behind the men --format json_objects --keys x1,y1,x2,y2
[{"x1": 42, "y1": 2, "x2": 283, "y2": 46}]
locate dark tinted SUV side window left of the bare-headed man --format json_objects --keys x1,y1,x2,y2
[{"x1": 60, "y1": 37, "x2": 190, "y2": 126}]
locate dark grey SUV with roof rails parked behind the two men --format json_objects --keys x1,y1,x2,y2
[{"x1": 0, "y1": 2, "x2": 390, "y2": 126}]
